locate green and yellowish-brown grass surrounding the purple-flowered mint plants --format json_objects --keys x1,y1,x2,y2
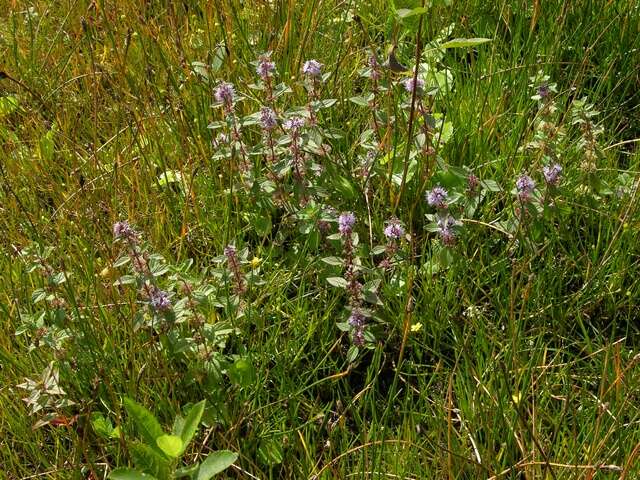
[{"x1": 0, "y1": 0, "x2": 640, "y2": 479}]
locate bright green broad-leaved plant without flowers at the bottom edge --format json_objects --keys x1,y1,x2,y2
[{"x1": 109, "y1": 398, "x2": 238, "y2": 480}]
